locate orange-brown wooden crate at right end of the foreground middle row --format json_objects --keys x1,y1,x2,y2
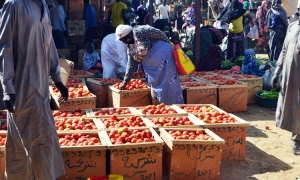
[{"x1": 203, "y1": 114, "x2": 250, "y2": 160}]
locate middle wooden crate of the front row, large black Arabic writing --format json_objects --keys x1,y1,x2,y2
[{"x1": 103, "y1": 128, "x2": 163, "y2": 180}]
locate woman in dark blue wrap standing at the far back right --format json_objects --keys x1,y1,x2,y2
[{"x1": 266, "y1": 0, "x2": 289, "y2": 61}]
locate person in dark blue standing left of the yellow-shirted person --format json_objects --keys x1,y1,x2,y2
[{"x1": 84, "y1": 0, "x2": 98, "y2": 44}]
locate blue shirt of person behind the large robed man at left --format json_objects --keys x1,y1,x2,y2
[{"x1": 50, "y1": 5, "x2": 67, "y2": 31}]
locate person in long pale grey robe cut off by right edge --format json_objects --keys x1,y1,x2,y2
[{"x1": 272, "y1": 19, "x2": 300, "y2": 155}]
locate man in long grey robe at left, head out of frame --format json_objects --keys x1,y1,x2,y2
[{"x1": 0, "y1": 0, "x2": 68, "y2": 180}]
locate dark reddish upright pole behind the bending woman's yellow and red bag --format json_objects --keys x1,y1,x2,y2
[{"x1": 194, "y1": 0, "x2": 202, "y2": 69}]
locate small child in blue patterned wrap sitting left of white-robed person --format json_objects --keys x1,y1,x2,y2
[{"x1": 83, "y1": 43, "x2": 102, "y2": 71}]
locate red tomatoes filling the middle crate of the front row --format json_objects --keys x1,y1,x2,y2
[{"x1": 108, "y1": 128, "x2": 155, "y2": 144}]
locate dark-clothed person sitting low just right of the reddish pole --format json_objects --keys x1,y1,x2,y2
[{"x1": 199, "y1": 45, "x2": 222, "y2": 71}]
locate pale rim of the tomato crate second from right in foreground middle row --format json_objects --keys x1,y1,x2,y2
[{"x1": 143, "y1": 114, "x2": 203, "y2": 130}]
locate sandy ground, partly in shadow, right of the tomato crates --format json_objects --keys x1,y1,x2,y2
[{"x1": 220, "y1": 105, "x2": 300, "y2": 180}]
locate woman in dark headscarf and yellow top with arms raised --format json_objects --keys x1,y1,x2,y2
[{"x1": 222, "y1": 0, "x2": 254, "y2": 61}]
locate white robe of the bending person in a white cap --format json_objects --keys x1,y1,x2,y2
[{"x1": 101, "y1": 33, "x2": 127, "y2": 78}]
